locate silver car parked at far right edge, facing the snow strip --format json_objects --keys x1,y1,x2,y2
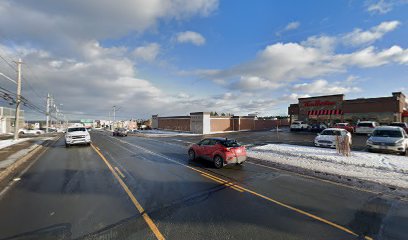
[{"x1": 367, "y1": 126, "x2": 408, "y2": 155}]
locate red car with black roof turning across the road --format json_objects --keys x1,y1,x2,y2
[{"x1": 188, "y1": 138, "x2": 247, "y2": 168}]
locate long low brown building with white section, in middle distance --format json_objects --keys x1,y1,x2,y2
[{"x1": 152, "y1": 112, "x2": 289, "y2": 134}]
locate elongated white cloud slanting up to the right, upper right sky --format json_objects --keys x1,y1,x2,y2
[{"x1": 343, "y1": 21, "x2": 400, "y2": 46}]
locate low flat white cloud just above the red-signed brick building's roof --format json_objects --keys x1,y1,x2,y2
[{"x1": 292, "y1": 79, "x2": 361, "y2": 95}]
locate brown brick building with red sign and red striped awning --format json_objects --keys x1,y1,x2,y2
[{"x1": 288, "y1": 92, "x2": 408, "y2": 124}]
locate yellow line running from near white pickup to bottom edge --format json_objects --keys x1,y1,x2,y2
[{"x1": 91, "y1": 144, "x2": 165, "y2": 240}]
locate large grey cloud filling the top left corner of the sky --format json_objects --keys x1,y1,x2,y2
[{"x1": 0, "y1": 0, "x2": 218, "y2": 57}]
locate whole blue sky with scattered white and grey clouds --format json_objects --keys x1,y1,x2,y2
[{"x1": 0, "y1": 0, "x2": 408, "y2": 119}]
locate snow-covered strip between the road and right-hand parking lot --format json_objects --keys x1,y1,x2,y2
[{"x1": 248, "y1": 144, "x2": 408, "y2": 188}]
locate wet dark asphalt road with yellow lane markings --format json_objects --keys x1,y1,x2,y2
[{"x1": 0, "y1": 132, "x2": 408, "y2": 239}]
